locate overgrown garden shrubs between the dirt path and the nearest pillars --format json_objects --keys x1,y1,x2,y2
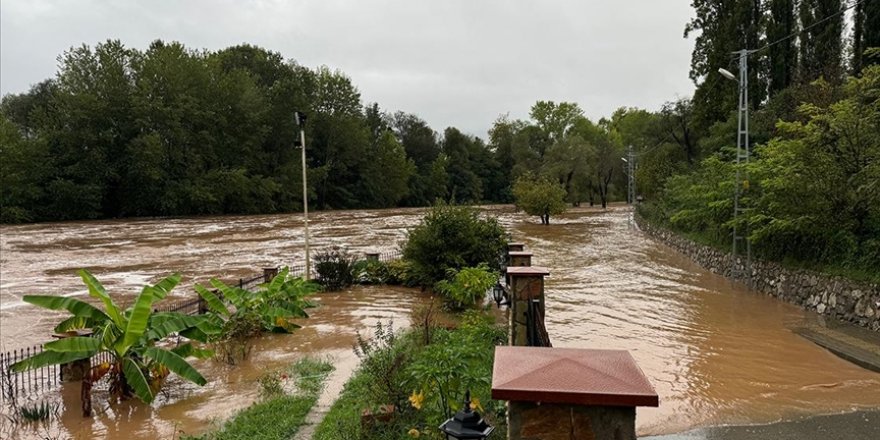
[{"x1": 313, "y1": 311, "x2": 506, "y2": 440}]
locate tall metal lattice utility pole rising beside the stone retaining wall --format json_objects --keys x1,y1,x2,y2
[{"x1": 731, "y1": 49, "x2": 752, "y2": 285}]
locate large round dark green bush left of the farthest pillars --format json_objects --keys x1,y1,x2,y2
[{"x1": 403, "y1": 203, "x2": 507, "y2": 286}]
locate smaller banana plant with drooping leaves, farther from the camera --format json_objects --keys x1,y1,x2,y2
[{"x1": 195, "y1": 267, "x2": 319, "y2": 333}]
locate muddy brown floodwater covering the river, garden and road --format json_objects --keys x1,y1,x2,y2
[{"x1": 0, "y1": 206, "x2": 880, "y2": 439}]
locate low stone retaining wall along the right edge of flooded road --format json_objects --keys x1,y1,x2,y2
[{"x1": 636, "y1": 215, "x2": 880, "y2": 331}]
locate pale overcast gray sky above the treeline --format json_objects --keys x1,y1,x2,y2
[{"x1": 0, "y1": 0, "x2": 694, "y2": 137}]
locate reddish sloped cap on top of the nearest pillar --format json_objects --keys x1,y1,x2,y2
[{"x1": 492, "y1": 346, "x2": 660, "y2": 406}]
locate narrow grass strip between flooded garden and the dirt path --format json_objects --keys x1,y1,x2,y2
[{"x1": 184, "y1": 358, "x2": 333, "y2": 440}]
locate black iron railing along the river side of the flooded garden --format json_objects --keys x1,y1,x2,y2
[{"x1": 0, "y1": 250, "x2": 400, "y2": 403}]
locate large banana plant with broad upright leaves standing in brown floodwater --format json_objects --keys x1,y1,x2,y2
[{"x1": 10, "y1": 269, "x2": 218, "y2": 413}]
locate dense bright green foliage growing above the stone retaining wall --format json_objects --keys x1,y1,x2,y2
[{"x1": 641, "y1": 66, "x2": 880, "y2": 281}]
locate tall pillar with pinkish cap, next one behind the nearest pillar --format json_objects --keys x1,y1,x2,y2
[{"x1": 507, "y1": 266, "x2": 550, "y2": 346}]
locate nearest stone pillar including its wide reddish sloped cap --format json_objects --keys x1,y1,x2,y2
[{"x1": 492, "y1": 347, "x2": 659, "y2": 440}]
